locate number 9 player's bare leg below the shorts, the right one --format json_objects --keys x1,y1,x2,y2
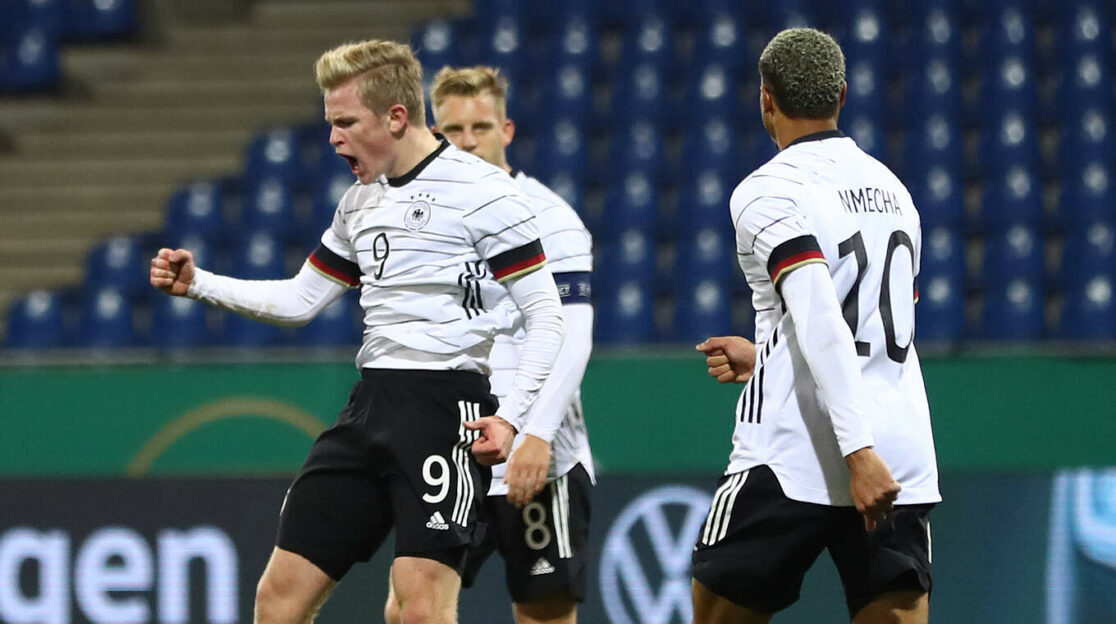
[{"x1": 392, "y1": 557, "x2": 461, "y2": 622}]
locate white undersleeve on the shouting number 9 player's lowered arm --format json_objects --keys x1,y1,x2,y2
[{"x1": 497, "y1": 265, "x2": 562, "y2": 432}]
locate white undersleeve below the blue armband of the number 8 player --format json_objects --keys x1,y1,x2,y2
[{"x1": 522, "y1": 304, "x2": 593, "y2": 442}]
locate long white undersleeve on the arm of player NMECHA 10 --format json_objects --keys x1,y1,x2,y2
[{"x1": 781, "y1": 263, "x2": 874, "y2": 457}]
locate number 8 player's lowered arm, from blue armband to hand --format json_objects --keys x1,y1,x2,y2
[{"x1": 504, "y1": 272, "x2": 593, "y2": 506}]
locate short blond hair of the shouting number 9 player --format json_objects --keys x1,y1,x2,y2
[{"x1": 314, "y1": 39, "x2": 426, "y2": 126}]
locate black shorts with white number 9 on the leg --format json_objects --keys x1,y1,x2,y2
[{"x1": 277, "y1": 368, "x2": 498, "y2": 580}]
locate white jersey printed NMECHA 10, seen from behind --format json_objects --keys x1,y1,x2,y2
[{"x1": 727, "y1": 131, "x2": 941, "y2": 506}]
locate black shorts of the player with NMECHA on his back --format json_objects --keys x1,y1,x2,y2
[{"x1": 693, "y1": 465, "x2": 934, "y2": 616}]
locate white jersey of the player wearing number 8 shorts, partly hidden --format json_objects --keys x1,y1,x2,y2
[{"x1": 489, "y1": 171, "x2": 596, "y2": 496}]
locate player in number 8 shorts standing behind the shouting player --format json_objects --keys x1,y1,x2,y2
[{"x1": 385, "y1": 67, "x2": 594, "y2": 624}]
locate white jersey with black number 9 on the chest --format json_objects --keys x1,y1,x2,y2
[{"x1": 309, "y1": 140, "x2": 546, "y2": 374}]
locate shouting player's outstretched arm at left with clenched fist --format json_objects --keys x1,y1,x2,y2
[{"x1": 151, "y1": 240, "x2": 359, "y2": 327}]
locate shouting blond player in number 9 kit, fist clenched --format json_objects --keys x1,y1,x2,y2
[{"x1": 151, "y1": 40, "x2": 562, "y2": 624}]
